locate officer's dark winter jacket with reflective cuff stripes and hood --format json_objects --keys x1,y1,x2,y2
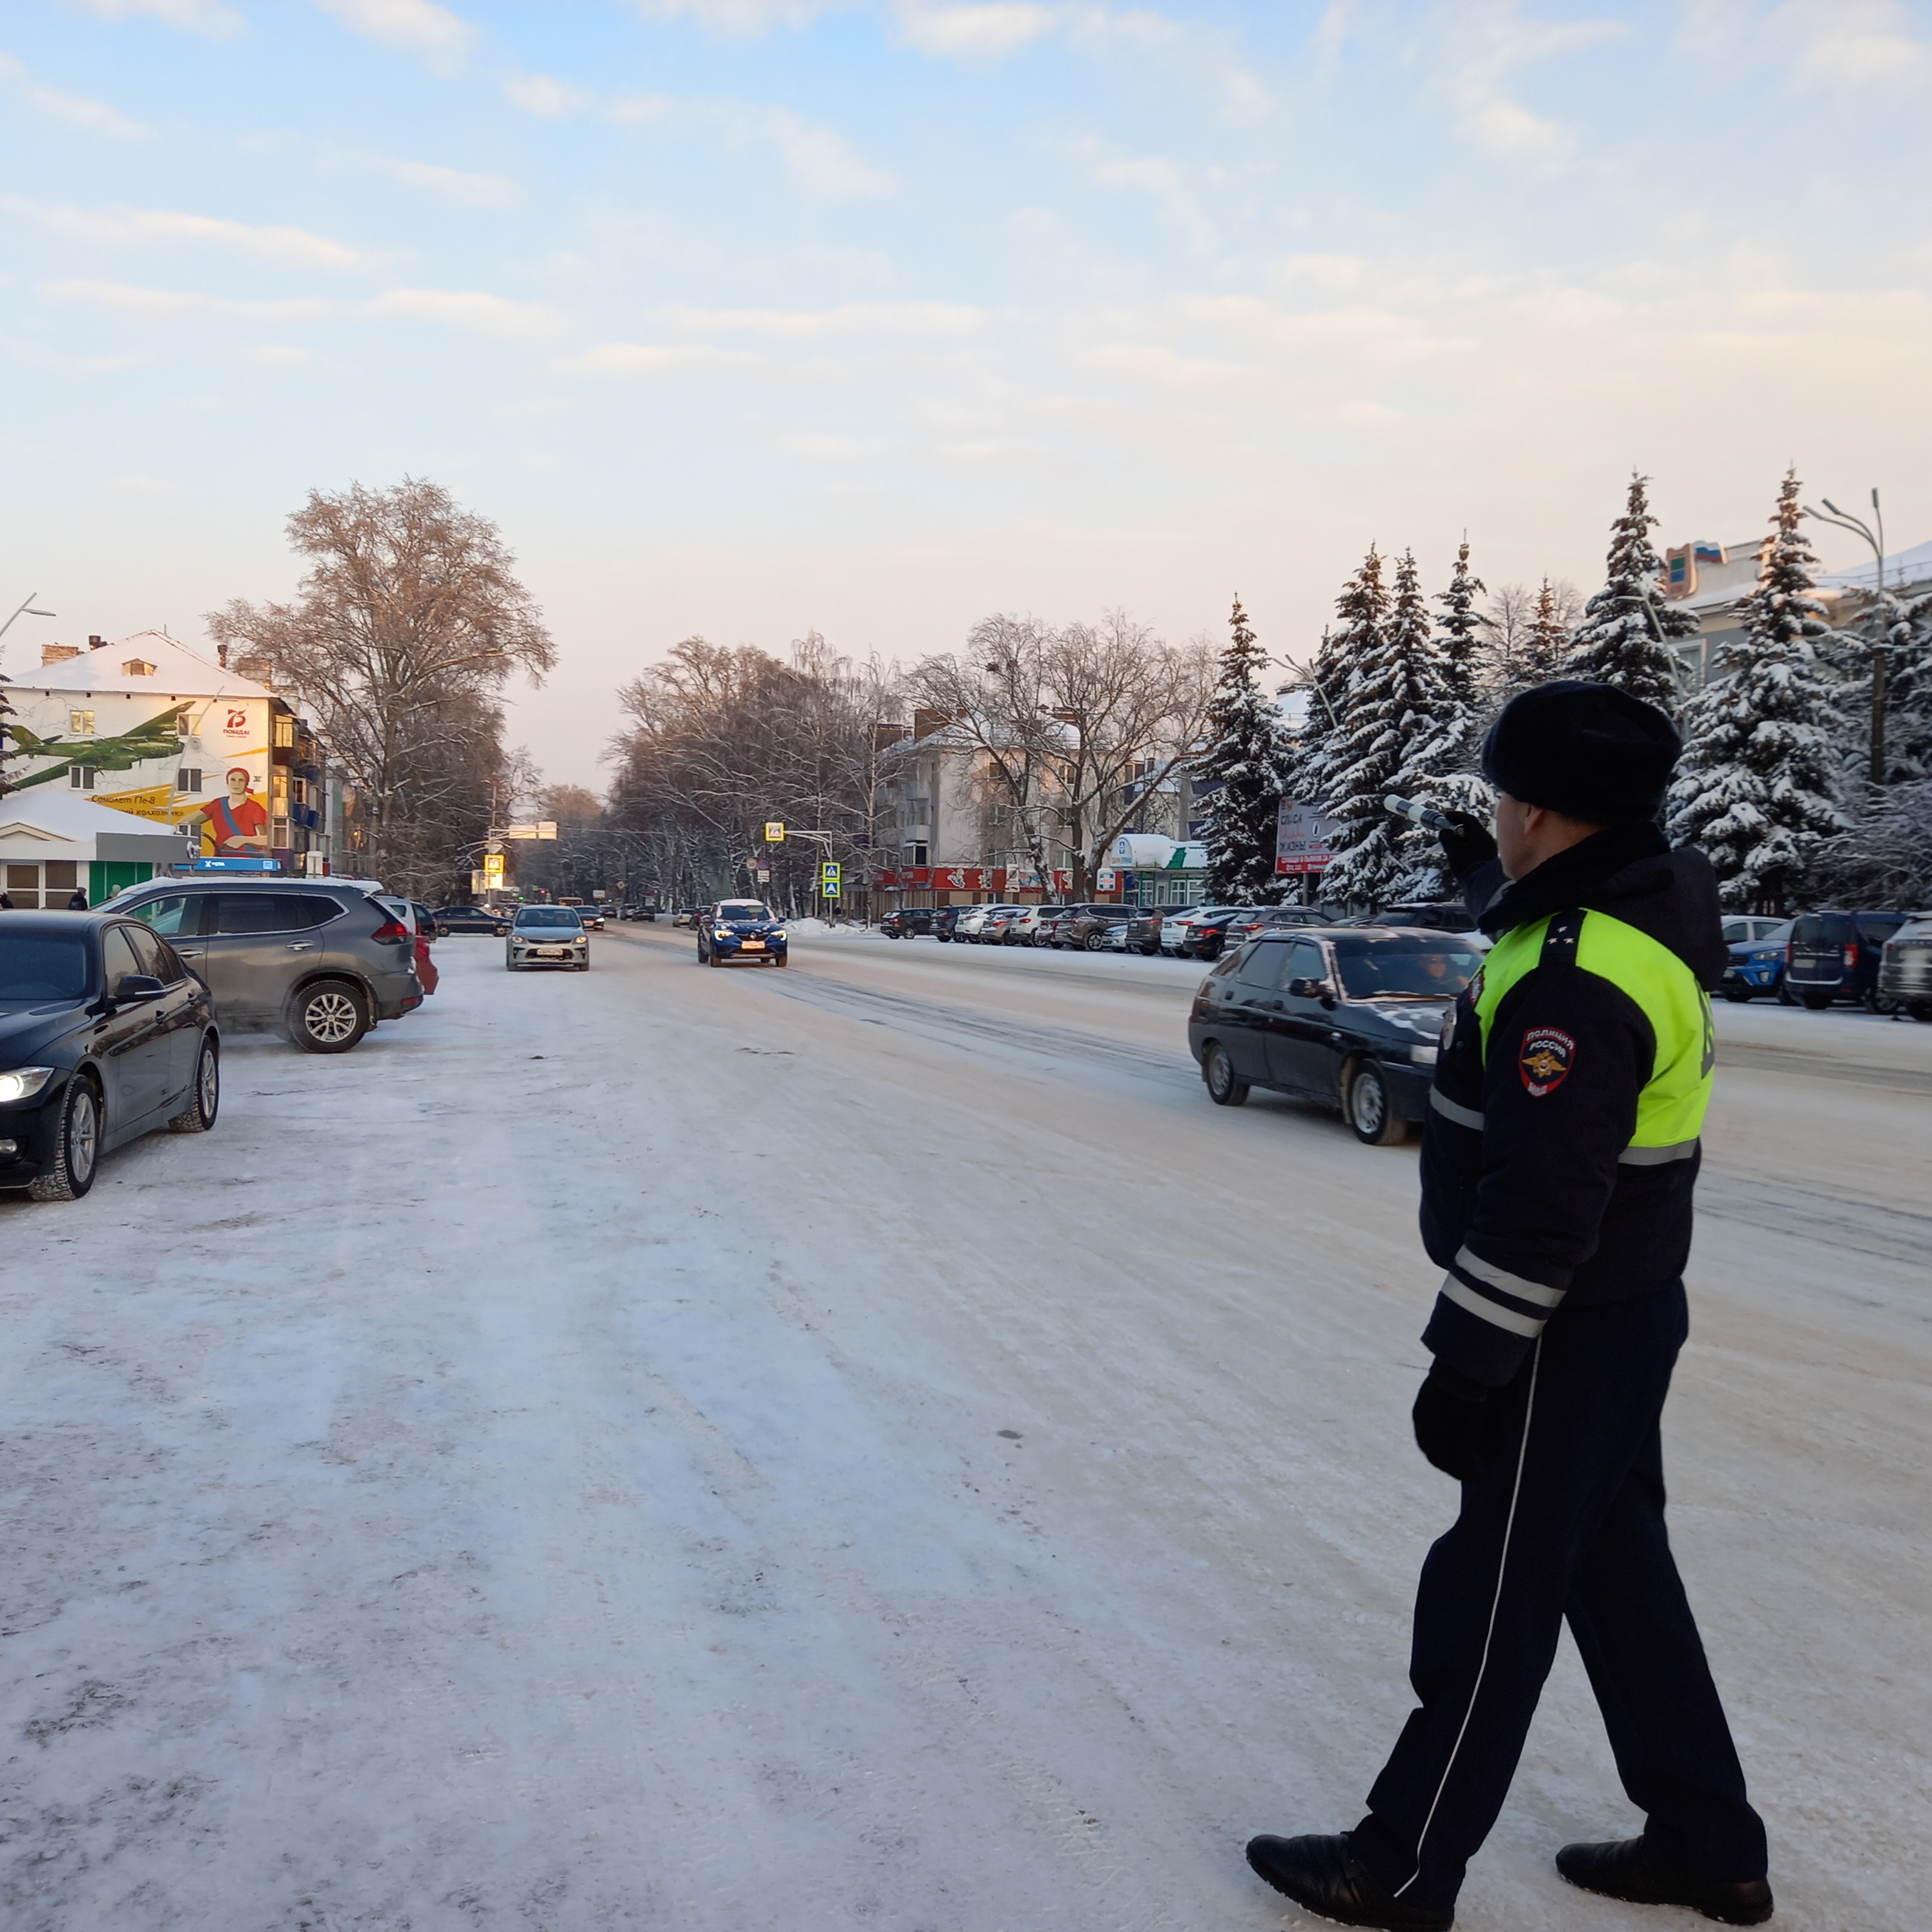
[{"x1": 1422, "y1": 825, "x2": 1727, "y2": 1387}]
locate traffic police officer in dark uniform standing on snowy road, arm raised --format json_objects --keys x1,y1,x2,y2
[{"x1": 1248, "y1": 682, "x2": 1772, "y2": 1932}]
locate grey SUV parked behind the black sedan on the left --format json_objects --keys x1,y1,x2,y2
[{"x1": 103, "y1": 877, "x2": 423, "y2": 1053}]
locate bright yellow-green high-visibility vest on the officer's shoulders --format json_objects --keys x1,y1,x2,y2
[{"x1": 1476, "y1": 912, "x2": 1718, "y2": 1167}]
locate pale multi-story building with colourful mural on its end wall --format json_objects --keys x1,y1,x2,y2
[{"x1": 8, "y1": 630, "x2": 344, "y2": 871}]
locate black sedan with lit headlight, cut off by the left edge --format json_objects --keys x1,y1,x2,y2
[{"x1": 0, "y1": 912, "x2": 220, "y2": 1202}]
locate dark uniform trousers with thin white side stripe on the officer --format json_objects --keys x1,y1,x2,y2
[{"x1": 1352, "y1": 1283, "x2": 1766, "y2": 1909}]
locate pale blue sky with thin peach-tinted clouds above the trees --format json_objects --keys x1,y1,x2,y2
[{"x1": 0, "y1": 0, "x2": 1932, "y2": 785}]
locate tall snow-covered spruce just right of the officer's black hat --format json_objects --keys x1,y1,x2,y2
[{"x1": 1671, "y1": 473, "x2": 1845, "y2": 912}]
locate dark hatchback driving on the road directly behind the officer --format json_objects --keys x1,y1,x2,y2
[{"x1": 1188, "y1": 925, "x2": 1482, "y2": 1146}]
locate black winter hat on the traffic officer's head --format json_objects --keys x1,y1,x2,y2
[{"x1": 1482, "y1": 678, "x2": 1683, "y2": 825}]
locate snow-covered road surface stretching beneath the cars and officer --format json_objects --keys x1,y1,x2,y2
[{"x1": 0, "y1": 925, "x2": 1932, "y2": 1932}]
